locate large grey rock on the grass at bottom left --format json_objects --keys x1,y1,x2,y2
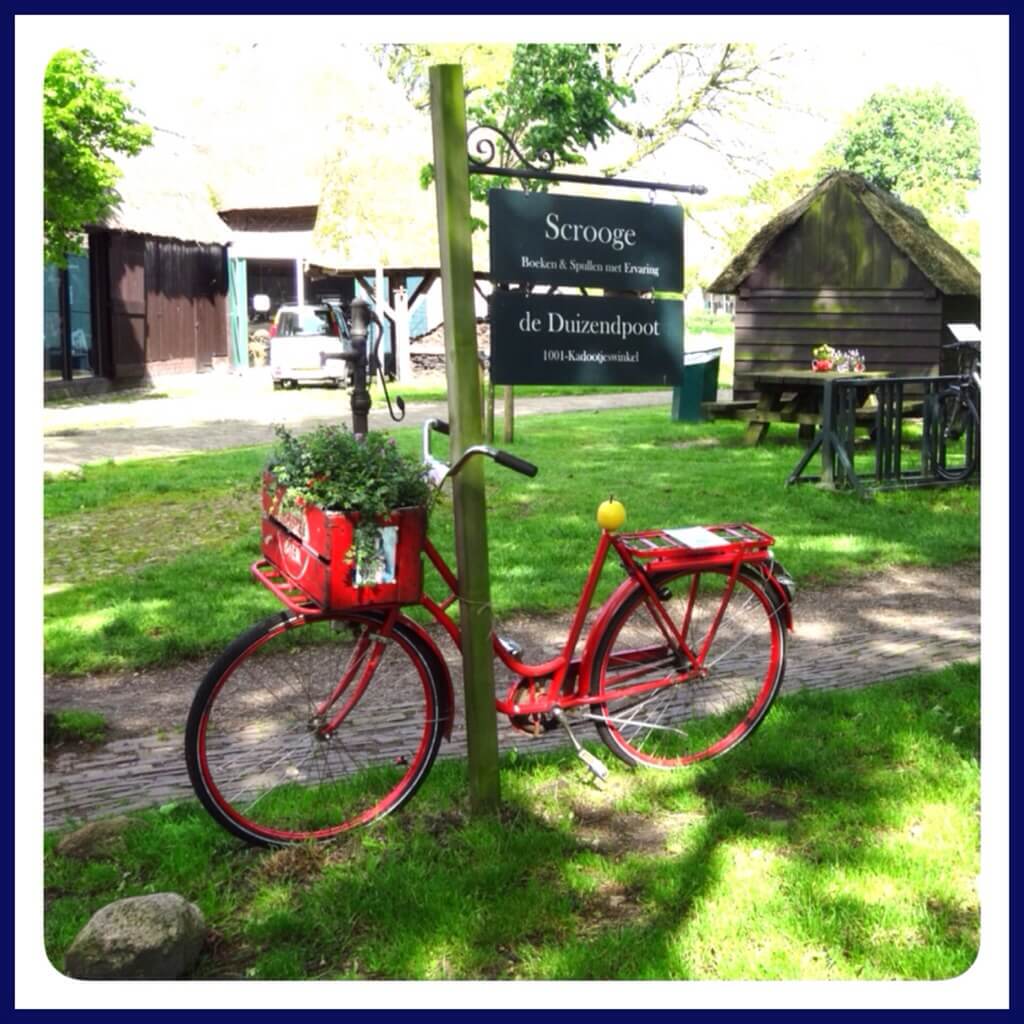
[{"x1": 65, "y1": 893, "x2": 206, "y2": 981}]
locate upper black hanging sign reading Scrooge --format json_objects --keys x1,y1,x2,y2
[{"x1": 488, "y1": 188, "x2": 683, "y2": 292}]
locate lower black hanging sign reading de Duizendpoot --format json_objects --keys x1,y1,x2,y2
[{"x1": 490, "y1": 291, "x2": 683, "y2": 386}]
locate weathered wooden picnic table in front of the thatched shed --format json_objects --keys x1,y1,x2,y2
[{"x1": 737, "y1": 370, "x2": 892, "y2": 444}]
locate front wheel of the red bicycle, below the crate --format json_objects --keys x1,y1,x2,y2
[{"x1": 185, "y1": 612, "x2": 451, "y2": 845}]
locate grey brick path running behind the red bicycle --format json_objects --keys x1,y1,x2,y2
[{"x1": 45, "y1": 565, "x2": 981, "y2": 827}]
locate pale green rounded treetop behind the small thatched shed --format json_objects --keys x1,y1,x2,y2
[{"x1": 821, "y1": 88, "x2": 981, "y2": 216}]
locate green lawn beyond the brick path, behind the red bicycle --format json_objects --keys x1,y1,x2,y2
[{"x1": 44, "y1": 409, "x2": 979, "y2": 674}]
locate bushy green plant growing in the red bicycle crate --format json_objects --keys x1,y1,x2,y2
[{"x1": 266, "y1": 425, "x2": 434, "y2": 564}]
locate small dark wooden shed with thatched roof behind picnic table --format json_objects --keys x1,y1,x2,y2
[{"x1": 708, "y1": 171, "x2": 981, "y2": 398}]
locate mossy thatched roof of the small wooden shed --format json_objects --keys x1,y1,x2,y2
[{"x1": 708, "y1": 171, "x2": 981, "y2": 295}]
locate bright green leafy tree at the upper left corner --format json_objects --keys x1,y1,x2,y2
[{"x1": 43, "y1": 49, "x2": 153, "y2": 266}]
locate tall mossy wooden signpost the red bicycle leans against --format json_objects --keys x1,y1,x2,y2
[{"x1": 430, "y1": 65, "x2": 500, "y2": 813}]
